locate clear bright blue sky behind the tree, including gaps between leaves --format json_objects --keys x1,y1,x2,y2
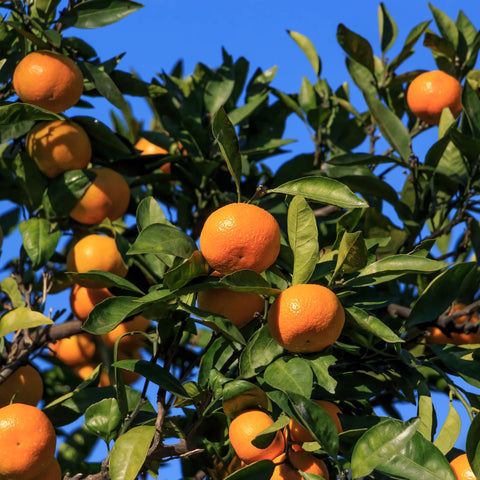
[{"x1": 0, "y1": 0, "x2": 480, "y2": 480}]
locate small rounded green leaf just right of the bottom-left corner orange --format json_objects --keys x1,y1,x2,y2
[{"x1": 85, "y1": 398, "x2": 123, "y2": 443}]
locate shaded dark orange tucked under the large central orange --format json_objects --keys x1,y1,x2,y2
[{"x1": 197, "y1": 288, "x2": 265, "y2": 328}]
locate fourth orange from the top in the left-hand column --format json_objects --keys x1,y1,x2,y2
[{"x1": 67, "y1": 234, "x2": 127, "y2": 280}]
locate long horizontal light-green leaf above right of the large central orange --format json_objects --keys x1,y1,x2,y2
[{"x1": 267, "y1": 177, "x2": 368, "y2": 208}]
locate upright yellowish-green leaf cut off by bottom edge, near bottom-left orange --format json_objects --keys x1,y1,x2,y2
[{"x1": 109, "y1": 426, "x2": 155, "y2": 480}]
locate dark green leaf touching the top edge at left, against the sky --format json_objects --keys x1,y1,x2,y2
[{"x1": 59, "y1": 0, "x2": 143, "y2": 28}]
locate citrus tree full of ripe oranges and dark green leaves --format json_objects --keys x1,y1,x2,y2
[{"x1": 0, "y1": 0, "x2": 480, "y2": 480}]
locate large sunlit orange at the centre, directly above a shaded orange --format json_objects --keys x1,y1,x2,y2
[{"x1": 200, "y1": 203, "x2": 280, "y2": 275}]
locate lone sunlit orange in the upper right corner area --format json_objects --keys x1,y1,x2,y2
[{"x1": 407, "y1": 70, "x2": 462, "y2": 125}]
